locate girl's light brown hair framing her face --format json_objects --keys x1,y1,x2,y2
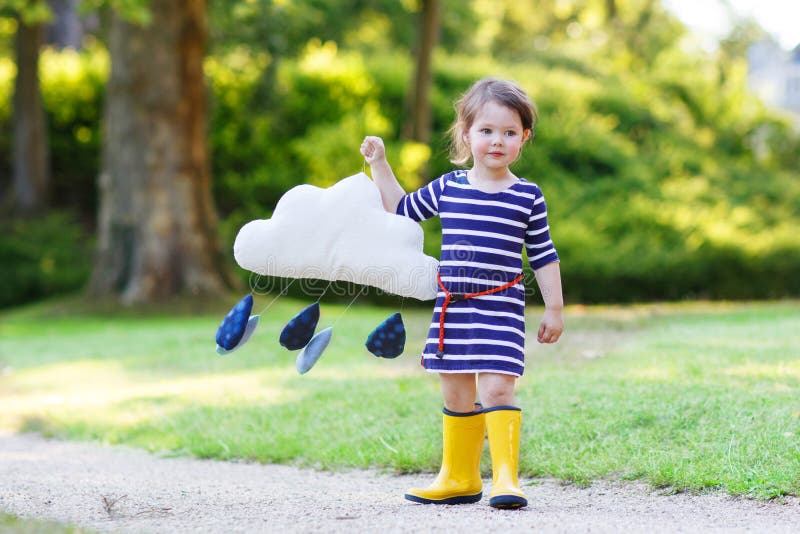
[{"x1": 448, "y1": 78, "x2": 539, "y2": 165}]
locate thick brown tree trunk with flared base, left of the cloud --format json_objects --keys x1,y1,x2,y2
[{"x1": 90, "y1": 0, "x2": 232, "y2": 303}]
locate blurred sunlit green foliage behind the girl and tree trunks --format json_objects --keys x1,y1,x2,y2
[{"x1": 0, "y1": 0, "x2": 800, "y2": 302}]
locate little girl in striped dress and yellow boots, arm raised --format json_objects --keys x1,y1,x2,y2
[{"x1": 361, "y1": 78, "x2": 563, "y2": 508}]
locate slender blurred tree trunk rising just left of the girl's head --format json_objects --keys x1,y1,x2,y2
[{"x1": 404, "y1": 0, "x2": 441, "y2": 144}]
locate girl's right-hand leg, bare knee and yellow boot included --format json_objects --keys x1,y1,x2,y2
[{"x1": 478, "y1": 373, "x2": 528, "y2": 508}]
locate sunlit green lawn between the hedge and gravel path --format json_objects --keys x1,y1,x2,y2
[{"x1": 0, "y1": 297, "x2": 800, "y2": 498}]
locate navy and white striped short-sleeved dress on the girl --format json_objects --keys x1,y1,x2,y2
[{"x1": 397, "y1": 170, "x2": 558, "y2": 376}]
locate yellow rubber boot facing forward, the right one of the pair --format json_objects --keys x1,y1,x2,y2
[{"x1": 484, "y1": 406, "x2": 528, "y2": 508}]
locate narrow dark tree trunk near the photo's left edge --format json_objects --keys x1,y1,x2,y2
[{"x1": 13, "y1": 19, "x2": 50, "y2": 213}]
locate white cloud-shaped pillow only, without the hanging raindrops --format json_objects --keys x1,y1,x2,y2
[{"x1": 233, "y1": 173, "x2": 439, "y2": 300}]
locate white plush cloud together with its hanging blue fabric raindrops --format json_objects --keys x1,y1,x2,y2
[{"x1": 217, "y1": 173, "x2": 439, "y2": 374}]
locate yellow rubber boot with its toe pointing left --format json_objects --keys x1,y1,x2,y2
[{"x1": 405, "y1": 408, "x2": 486, "y2": 504}]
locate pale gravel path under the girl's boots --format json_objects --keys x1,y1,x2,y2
[{"x1": 0, "y1": 434, "x2": 800, "y2": 534}]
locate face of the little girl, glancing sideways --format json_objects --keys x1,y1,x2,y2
[{"x1": 465, "y1": 101, "x2": 530, "y2": 174}]
